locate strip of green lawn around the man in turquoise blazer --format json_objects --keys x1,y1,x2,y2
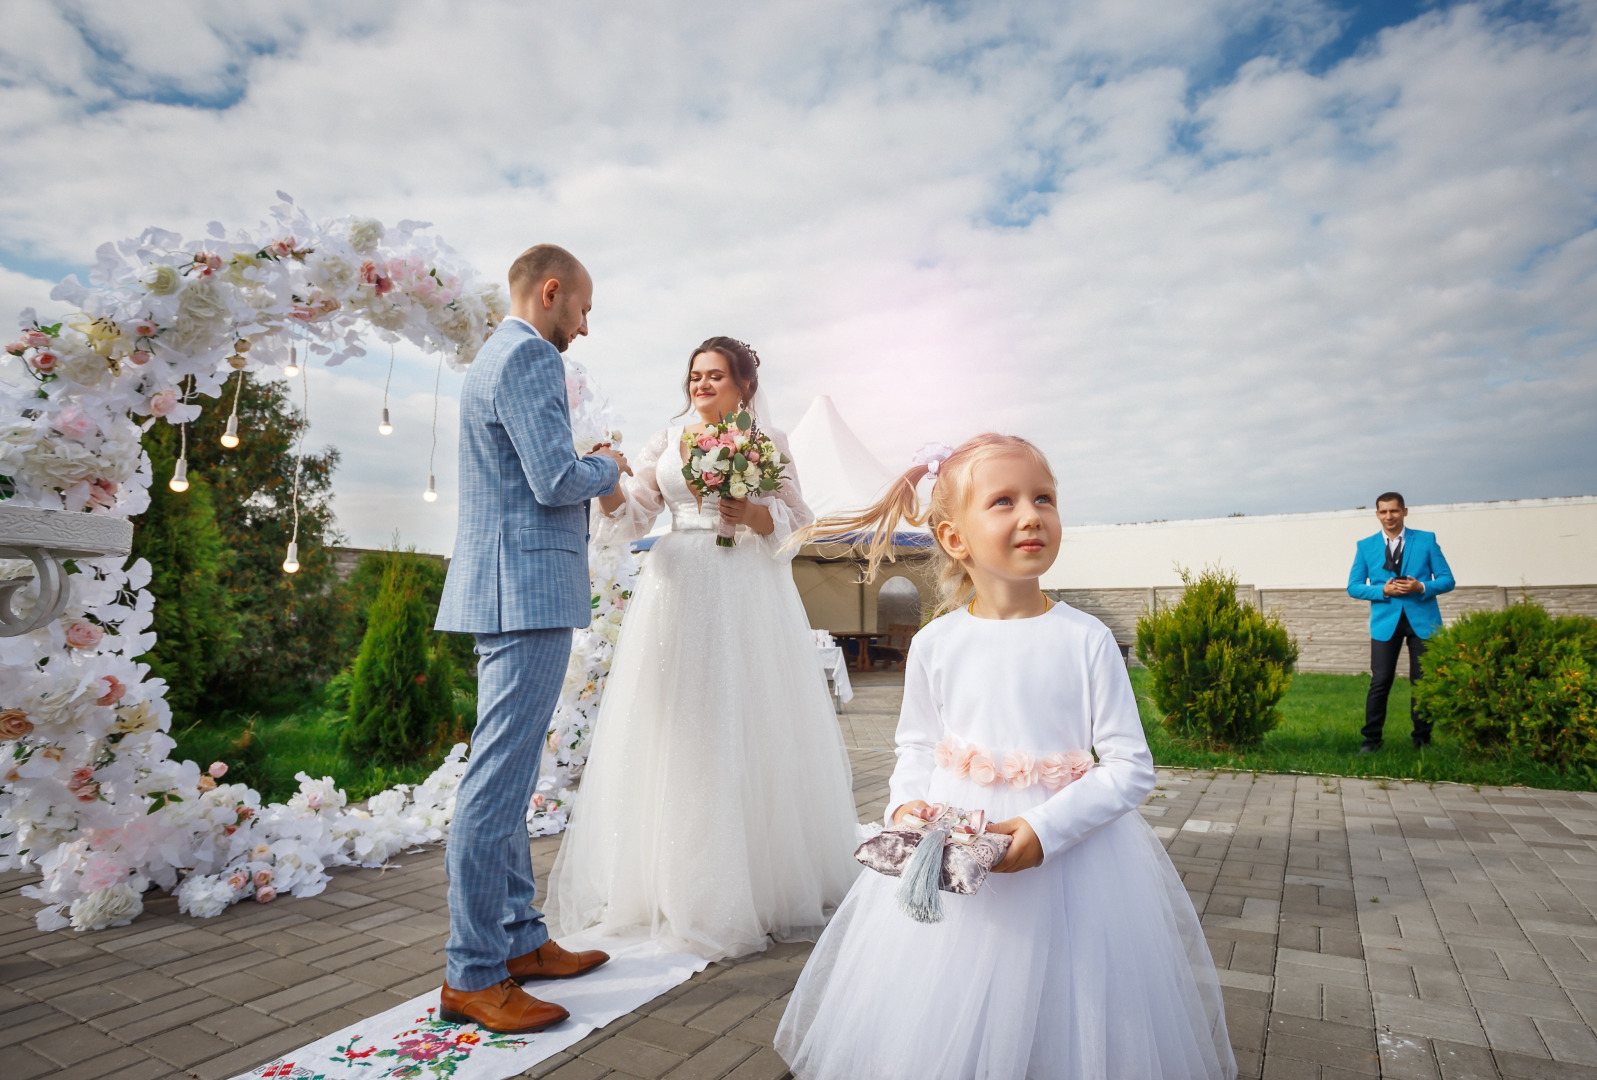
[{"x1": 1131, "y1": 668, "x2": 1597, "y2": 791}]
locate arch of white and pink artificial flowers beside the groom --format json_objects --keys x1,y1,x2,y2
[{"x1": 0, "y1": 192, "x2": 634, "y2": 930}]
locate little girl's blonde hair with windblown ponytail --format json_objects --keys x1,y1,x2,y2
[{"x1": 804, "y1": 435, "x2": 1054, "y2": 618}]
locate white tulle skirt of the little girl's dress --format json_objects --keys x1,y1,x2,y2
[{"x1": 776, "y1": 770, "x2": 1236, "y2": 1080}]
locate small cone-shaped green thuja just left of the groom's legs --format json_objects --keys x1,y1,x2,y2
[{"x1": 340, "y1": 553, "x2": 458, "y2": 765}]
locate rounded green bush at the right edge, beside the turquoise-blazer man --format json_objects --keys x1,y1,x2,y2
[{"x1": 1415, "y1": 599, "x2": 1597, "y2": 767}]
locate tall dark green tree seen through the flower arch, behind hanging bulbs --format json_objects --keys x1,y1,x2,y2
[{"x1": 144, "y1": 375, "x2": 348, "y2": 709}]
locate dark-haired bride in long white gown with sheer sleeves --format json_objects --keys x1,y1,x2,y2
[{"x1": 548, "y1": 337, "x2": 859, "y2": 960}]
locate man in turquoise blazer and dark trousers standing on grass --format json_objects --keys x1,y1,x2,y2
[{"x1": 1348, "y1": 490, "x2": 1453, "y2": 754}]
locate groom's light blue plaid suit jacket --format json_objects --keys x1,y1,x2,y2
[{"x1": 434, "y1": 321, "x2": 620, "y2": 634}]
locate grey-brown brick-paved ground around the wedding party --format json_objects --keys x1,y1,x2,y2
[{"x1": 9, "y1": 674, "x2": 1597, "y2": 1080}]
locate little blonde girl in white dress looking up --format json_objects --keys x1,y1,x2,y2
[{"x1": 776, "y1": 435, "x2": 1236, "y2": 1080}]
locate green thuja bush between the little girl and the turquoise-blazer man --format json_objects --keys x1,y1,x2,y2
[{"x1": 1137, "y1": 569, "x2": 1298, "y2": 746}]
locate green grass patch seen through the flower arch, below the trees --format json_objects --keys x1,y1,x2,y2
[{"x1": 172, "y1": 701, "x2": 447, "y2": 802}]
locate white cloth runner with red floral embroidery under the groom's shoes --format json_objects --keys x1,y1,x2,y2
[{"x1": 233, "y1": 936, "x2": 704, "y2": 1080}]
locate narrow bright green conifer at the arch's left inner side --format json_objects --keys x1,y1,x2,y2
[{"x1": 133, "y1": 443, "x2": 238, "y2": 721}]
